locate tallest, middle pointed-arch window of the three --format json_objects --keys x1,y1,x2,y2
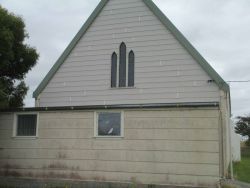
[{"x1": 119, "y1": 42, "x2": 127, "y2": 87}]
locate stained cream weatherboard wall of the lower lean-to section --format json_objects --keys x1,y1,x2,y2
[{"x1": 0, "y1": 108, "x2": 220, "y2": 186}]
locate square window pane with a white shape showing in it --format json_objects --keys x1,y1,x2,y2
[{"x1": 98, "y1": 112, "x2": 121, "y2": 136}]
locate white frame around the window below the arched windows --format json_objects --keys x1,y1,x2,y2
[{"x1": 94, "y1": 110, "x2": 124, "y2": 139}]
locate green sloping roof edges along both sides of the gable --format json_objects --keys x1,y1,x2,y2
[{"x1": 33, "y1": 0, "x2": 230, "y2": 98}]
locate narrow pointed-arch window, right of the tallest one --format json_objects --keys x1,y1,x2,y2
[{"x1": 128, "y1": 50, "x2": 135, "y2": 87}]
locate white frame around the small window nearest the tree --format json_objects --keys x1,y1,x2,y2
[{"x1": 12, "y1": 112, "x2": 39, "y2": 139}]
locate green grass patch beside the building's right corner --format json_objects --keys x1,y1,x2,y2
[{"x1": 234, "y1": 147, "x2": 250, "y2": 183}]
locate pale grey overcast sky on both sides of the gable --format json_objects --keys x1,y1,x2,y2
[{"x1": 0, "y1": 0, "x2": 250, "y2": 116}]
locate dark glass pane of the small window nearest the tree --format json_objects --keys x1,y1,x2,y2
[{"x1": 17, "y1": 114, "x2": 37, "y2": 136}]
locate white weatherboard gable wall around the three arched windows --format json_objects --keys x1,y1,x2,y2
[{"x1": 38, "y1": 0, "x2": 219, "y2": 107}]
